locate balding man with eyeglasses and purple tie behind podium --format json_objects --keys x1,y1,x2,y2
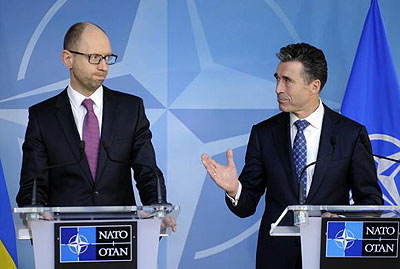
[{"x1": 17, "y1": 23, "x2": 166, "y2": 206}]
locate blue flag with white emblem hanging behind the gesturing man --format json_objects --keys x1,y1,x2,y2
[{"x1": 341, "y1": 0, "x2": 400, "y2": 205}]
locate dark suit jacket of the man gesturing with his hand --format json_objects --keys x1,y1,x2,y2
[{"x1": 226, "y1": 103, "x2": 383, "y2": 268}]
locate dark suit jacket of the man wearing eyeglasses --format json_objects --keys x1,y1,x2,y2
[{"x1": 17, "y1": 87, "x2": 165, "y2": 206}]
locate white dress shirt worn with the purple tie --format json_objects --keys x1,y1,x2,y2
[{"x1": 67, "y1": 85, "x2": 103, "y2": 140}]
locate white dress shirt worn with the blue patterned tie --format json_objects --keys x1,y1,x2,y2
[{"x1": 226, "y1": 99, "x2": 325, "y2": 206}]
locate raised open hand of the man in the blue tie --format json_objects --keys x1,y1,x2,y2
[{"x1": 201, "y1": 149, "x2": 239, "y2": 197}]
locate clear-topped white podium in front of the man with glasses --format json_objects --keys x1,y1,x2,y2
[{"x1": 14, "y1": 205, "x2": 179, "y2": 269}]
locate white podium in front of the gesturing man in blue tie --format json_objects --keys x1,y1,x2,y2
[{"x1": 270, "y1": 205, "x2": 400, "y2": 269}]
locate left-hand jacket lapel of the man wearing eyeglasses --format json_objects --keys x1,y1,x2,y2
[{"x1": 56, "y1": 89, "x2": 93, "y2": 184}]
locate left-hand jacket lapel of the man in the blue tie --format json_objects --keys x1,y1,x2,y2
[{"x1": 273, "y1": 113, "x2": 297, "y2": 197}]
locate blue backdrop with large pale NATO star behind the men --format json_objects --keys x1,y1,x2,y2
[{"x1": 0, "y1": 0, "x2": 400, "y2": 268}]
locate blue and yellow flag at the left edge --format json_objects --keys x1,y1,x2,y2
[{"x1": 0, "y1": 161, "x2": 18, "y2": 269}]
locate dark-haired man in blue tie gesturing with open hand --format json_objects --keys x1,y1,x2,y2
[{"x1": 202, "y1": 43, "x2": 383, "y2": 269}]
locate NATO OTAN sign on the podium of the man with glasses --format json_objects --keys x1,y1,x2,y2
[{"x1": 55, "y1": 222, "x2": 137, "y2": 268}]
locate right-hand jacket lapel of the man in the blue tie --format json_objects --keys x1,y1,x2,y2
[{"x1": 306, "y1": 105, "x2": 336, "y2": 202}]
